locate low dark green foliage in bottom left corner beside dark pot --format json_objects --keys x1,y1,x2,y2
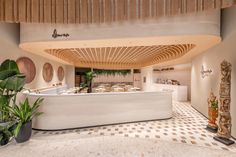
[{"x1": 0, "y1": 122, "x2": 15, "y2": 146}]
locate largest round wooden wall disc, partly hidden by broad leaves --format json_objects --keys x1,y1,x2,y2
[{"x1": 16, "y1": 57, "x2": 36, "y2": 83}]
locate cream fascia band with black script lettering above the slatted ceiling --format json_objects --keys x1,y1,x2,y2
[{"x1": 21, "y1": 10, "x2": 220, "y2": 43}]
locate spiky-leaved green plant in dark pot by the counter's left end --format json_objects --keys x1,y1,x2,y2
[{"x1": 7, "y1": 98, "x2": 43, "y2": 143}]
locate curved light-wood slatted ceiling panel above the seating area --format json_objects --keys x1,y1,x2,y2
[{"x1": 45, "y1": 44, "x2": 195, "y2": 69}]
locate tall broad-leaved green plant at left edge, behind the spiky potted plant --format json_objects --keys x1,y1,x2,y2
[{"x1": 0, "y1": 59, "x2": 25, "y2": 126}]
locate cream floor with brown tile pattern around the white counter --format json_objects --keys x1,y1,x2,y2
[{"x1": 33, "y1": 102, "x2": 236, "y2": 152}]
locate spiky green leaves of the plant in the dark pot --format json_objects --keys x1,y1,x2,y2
[{"x1": 6, "y1": 98, "x2": 43, "y2": 136}]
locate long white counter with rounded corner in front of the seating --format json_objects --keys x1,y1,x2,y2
[{"x1": 26, "y1": 92, "x2": 172, "y2": 130}]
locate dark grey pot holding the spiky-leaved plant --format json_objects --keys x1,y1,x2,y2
[{"x1": 15, "y1": 121, "x2": 32, "y2": 143}]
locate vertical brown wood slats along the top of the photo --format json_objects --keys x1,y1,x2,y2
[{"x1": 0, "y1": 0, "x2": 236, "y2": 24}]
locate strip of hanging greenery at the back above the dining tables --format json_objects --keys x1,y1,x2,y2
[{"x1": 93, "y1": 69, "x2": 131, "y2": 76}]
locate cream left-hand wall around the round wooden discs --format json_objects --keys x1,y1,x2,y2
[{"x1": 0, "y1": 23, "x2": 66, "y2": 89}]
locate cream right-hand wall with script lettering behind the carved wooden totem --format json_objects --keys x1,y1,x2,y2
[{"x1": 191, "y1": 7, "x2": 236, "y2": 137}]
